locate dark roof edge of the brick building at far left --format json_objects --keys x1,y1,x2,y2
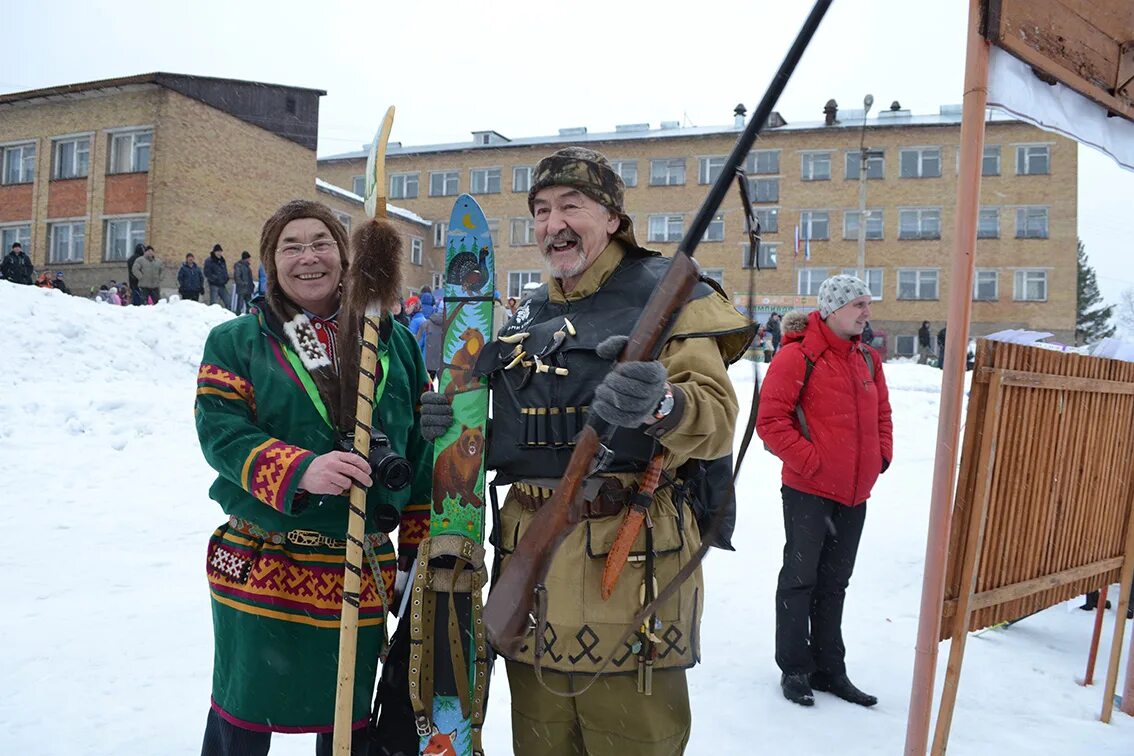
[{"x1": 0, "y1": 71, "x2": 327, "y2": 150}]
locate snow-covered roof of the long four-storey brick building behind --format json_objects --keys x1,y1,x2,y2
[{"x1": 320, "y1": 105, "x2": 1017, "y2": 162}]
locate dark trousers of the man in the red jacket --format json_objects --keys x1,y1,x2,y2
[{"x1": 776, "y1": 486, "x2": 866, "y2": 674}]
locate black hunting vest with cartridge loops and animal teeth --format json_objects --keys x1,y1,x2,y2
[{"x1": 476, "y1": 250, "x2": 713, "y2": 483}]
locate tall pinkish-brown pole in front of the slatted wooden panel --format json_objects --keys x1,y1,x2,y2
[{"x1": 905, "y1": 0, "x2": 989, "y2": 756}]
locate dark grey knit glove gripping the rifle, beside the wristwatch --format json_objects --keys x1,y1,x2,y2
[{"x1": 591, "y1": 335, "x2": 668, "y2": 427}]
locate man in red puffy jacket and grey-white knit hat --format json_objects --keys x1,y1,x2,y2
[{"x1": 756, "y1": 275, "x2": 894, "y2": 706}]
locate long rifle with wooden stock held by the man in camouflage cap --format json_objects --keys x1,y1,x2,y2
[{"x1": 484, "y1": 0, "x2": 831, "y2": 655}]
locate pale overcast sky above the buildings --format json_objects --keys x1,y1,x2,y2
[{"x1": 8, "y1": 0, "x2": 1134, "y2": 321}]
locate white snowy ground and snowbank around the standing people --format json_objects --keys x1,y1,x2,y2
[{"x1": 0, "y1": 282, "x2": 1134, "y2": 756}]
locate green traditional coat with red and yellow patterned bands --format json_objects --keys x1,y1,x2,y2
[{"x1": 195, "y1": 314, "x2": 433, "y2": 732}]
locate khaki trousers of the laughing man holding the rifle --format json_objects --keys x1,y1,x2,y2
[{"x1": 506, "y1": 661, "x2": 692, "y2": 756}]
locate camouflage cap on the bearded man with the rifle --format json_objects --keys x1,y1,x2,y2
[{"x1": 527, "y1": 146, "x2": 637, "y2": 247}]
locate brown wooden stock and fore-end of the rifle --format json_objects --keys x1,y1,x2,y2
[{"x1": 484, "y1": 252, "x2": 700, "y2": 655}]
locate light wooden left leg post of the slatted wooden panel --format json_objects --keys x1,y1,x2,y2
[{"x1": 934, "y1": 371, "x2": 1004, "y2": 756}]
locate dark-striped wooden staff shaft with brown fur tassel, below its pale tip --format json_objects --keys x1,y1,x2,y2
[{"x1": 335, "y1": 220, "x2": 401, "y2": 754}]
